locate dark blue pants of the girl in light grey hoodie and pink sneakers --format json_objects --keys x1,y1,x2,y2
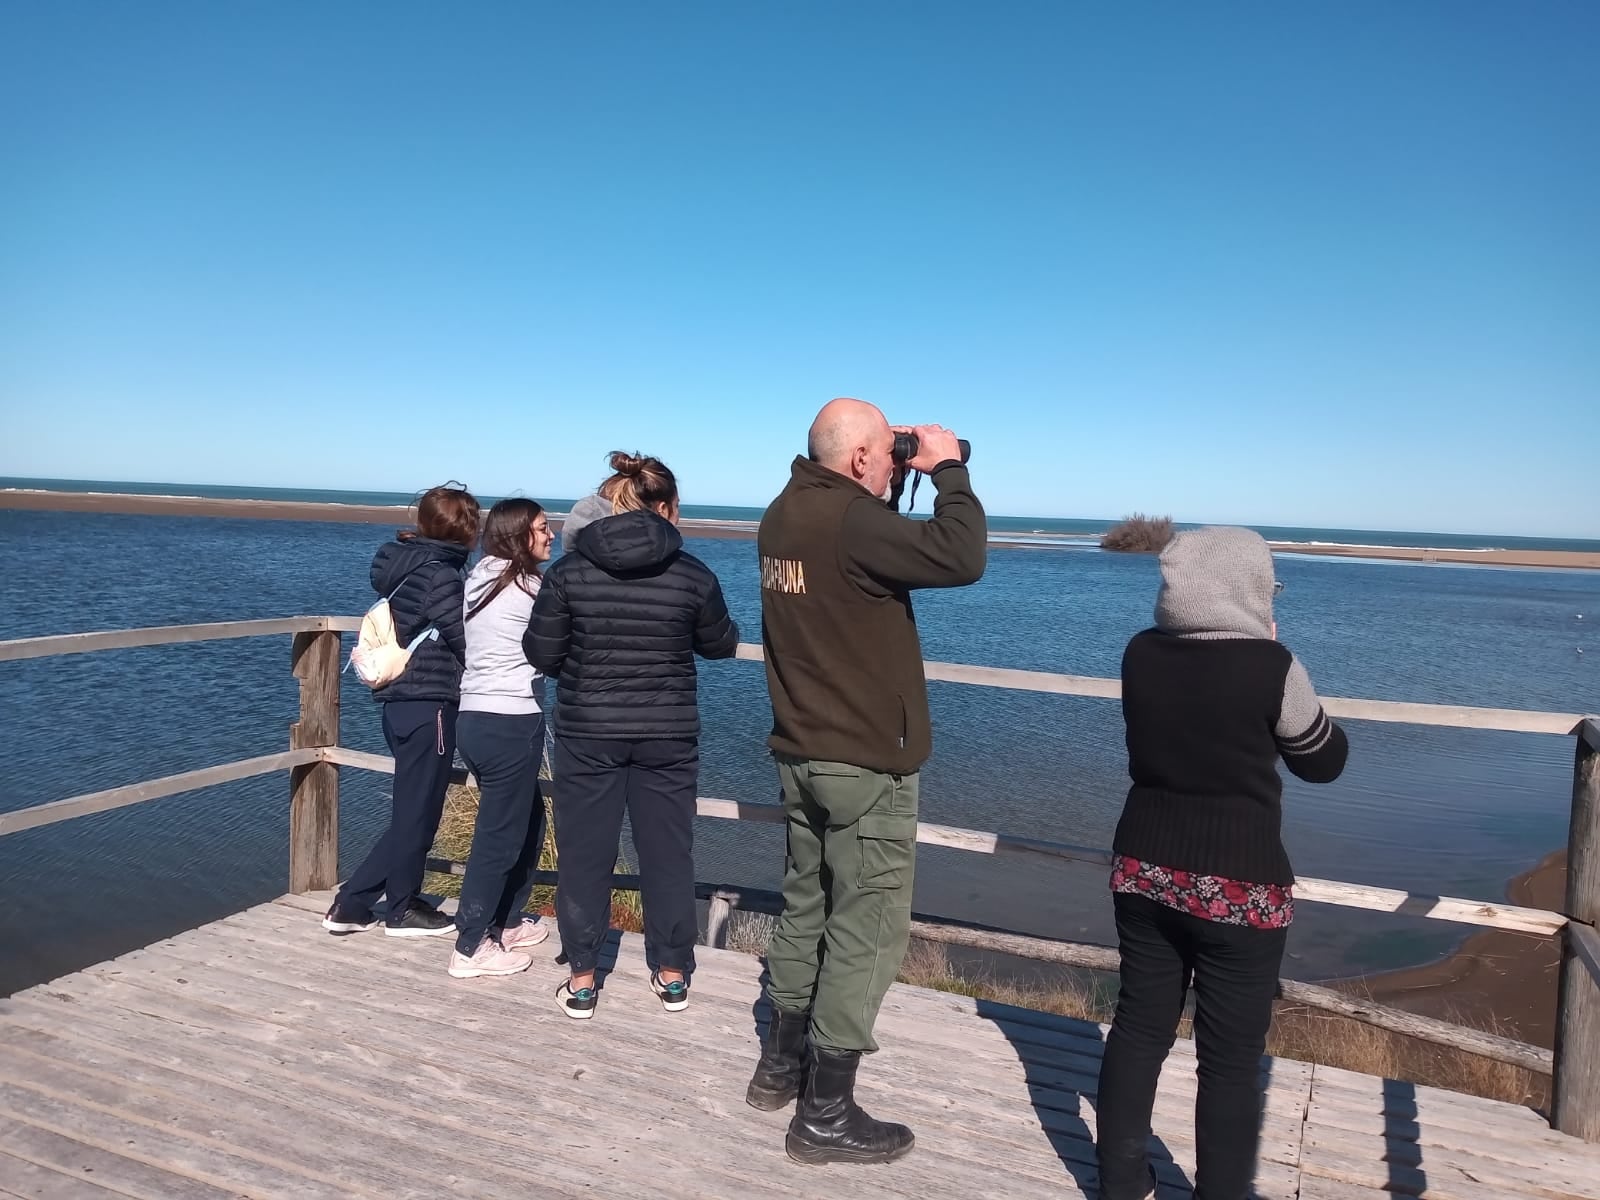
[{"x1": 456, "y1": 712, "x2": 544, "y2": 955}]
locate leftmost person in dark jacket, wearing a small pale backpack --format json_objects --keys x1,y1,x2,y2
[{"x1": 322, "y1": 486, "x2": 480, "y2": 938}]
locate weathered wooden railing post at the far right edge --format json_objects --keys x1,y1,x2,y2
[{"x1": 1550, "y1": 717, "x2": 1600, "y2": 1142}]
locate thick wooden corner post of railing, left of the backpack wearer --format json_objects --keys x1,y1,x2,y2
[{"x1": 290, "y1": 630, "x2": 339, "y2": 893}]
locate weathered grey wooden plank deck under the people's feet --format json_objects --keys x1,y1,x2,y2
[{"x1": 0, "y1": 894, "x2": 1600, "y2": 1200}]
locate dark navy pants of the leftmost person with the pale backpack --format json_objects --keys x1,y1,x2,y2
[{"x1": 338, "y1": 701, "x2": 456, "y2": 923}]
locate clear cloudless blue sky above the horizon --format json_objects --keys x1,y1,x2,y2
[{"x1": 0, "y1": 0, "x2": 1600, "y2": 536}]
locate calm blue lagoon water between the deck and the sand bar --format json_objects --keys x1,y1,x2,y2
[{"x1": 0, "y1": 510, "x2": 1600, "y2": 990}]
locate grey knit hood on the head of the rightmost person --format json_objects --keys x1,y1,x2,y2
[{"x1": 1155, "y1": 525, "x2": 1272, "y2": 638}]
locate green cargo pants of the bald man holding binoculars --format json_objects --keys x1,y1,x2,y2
[{"x1": 766, "y1": 758, "x2": 917, "y2": 1050}]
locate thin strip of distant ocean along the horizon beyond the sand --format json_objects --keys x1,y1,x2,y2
[{"x1": 9, "y1": 475, "x2": 1600, "y2": 554}]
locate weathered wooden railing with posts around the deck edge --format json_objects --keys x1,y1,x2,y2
[{"x1": 0, "y1": 616, "x2": 1600, "y2": 1141}]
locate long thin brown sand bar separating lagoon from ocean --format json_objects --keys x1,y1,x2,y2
[{"x1": 9, "y1": 488, "x2": 1600, "y2": 571}]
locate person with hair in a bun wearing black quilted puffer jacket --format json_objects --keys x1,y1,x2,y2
[{"x1": 523, "y1": 451, "x2": 739, "y2": 1019}]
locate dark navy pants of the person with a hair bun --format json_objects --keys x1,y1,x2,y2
[{"x1": 554, "y1": 733, "x2": 699, "y2": 974}]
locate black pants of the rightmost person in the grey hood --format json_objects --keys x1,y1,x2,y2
[{"x1": 1096, "y1": 894, "x2": 1288, "y2": 1200}]
